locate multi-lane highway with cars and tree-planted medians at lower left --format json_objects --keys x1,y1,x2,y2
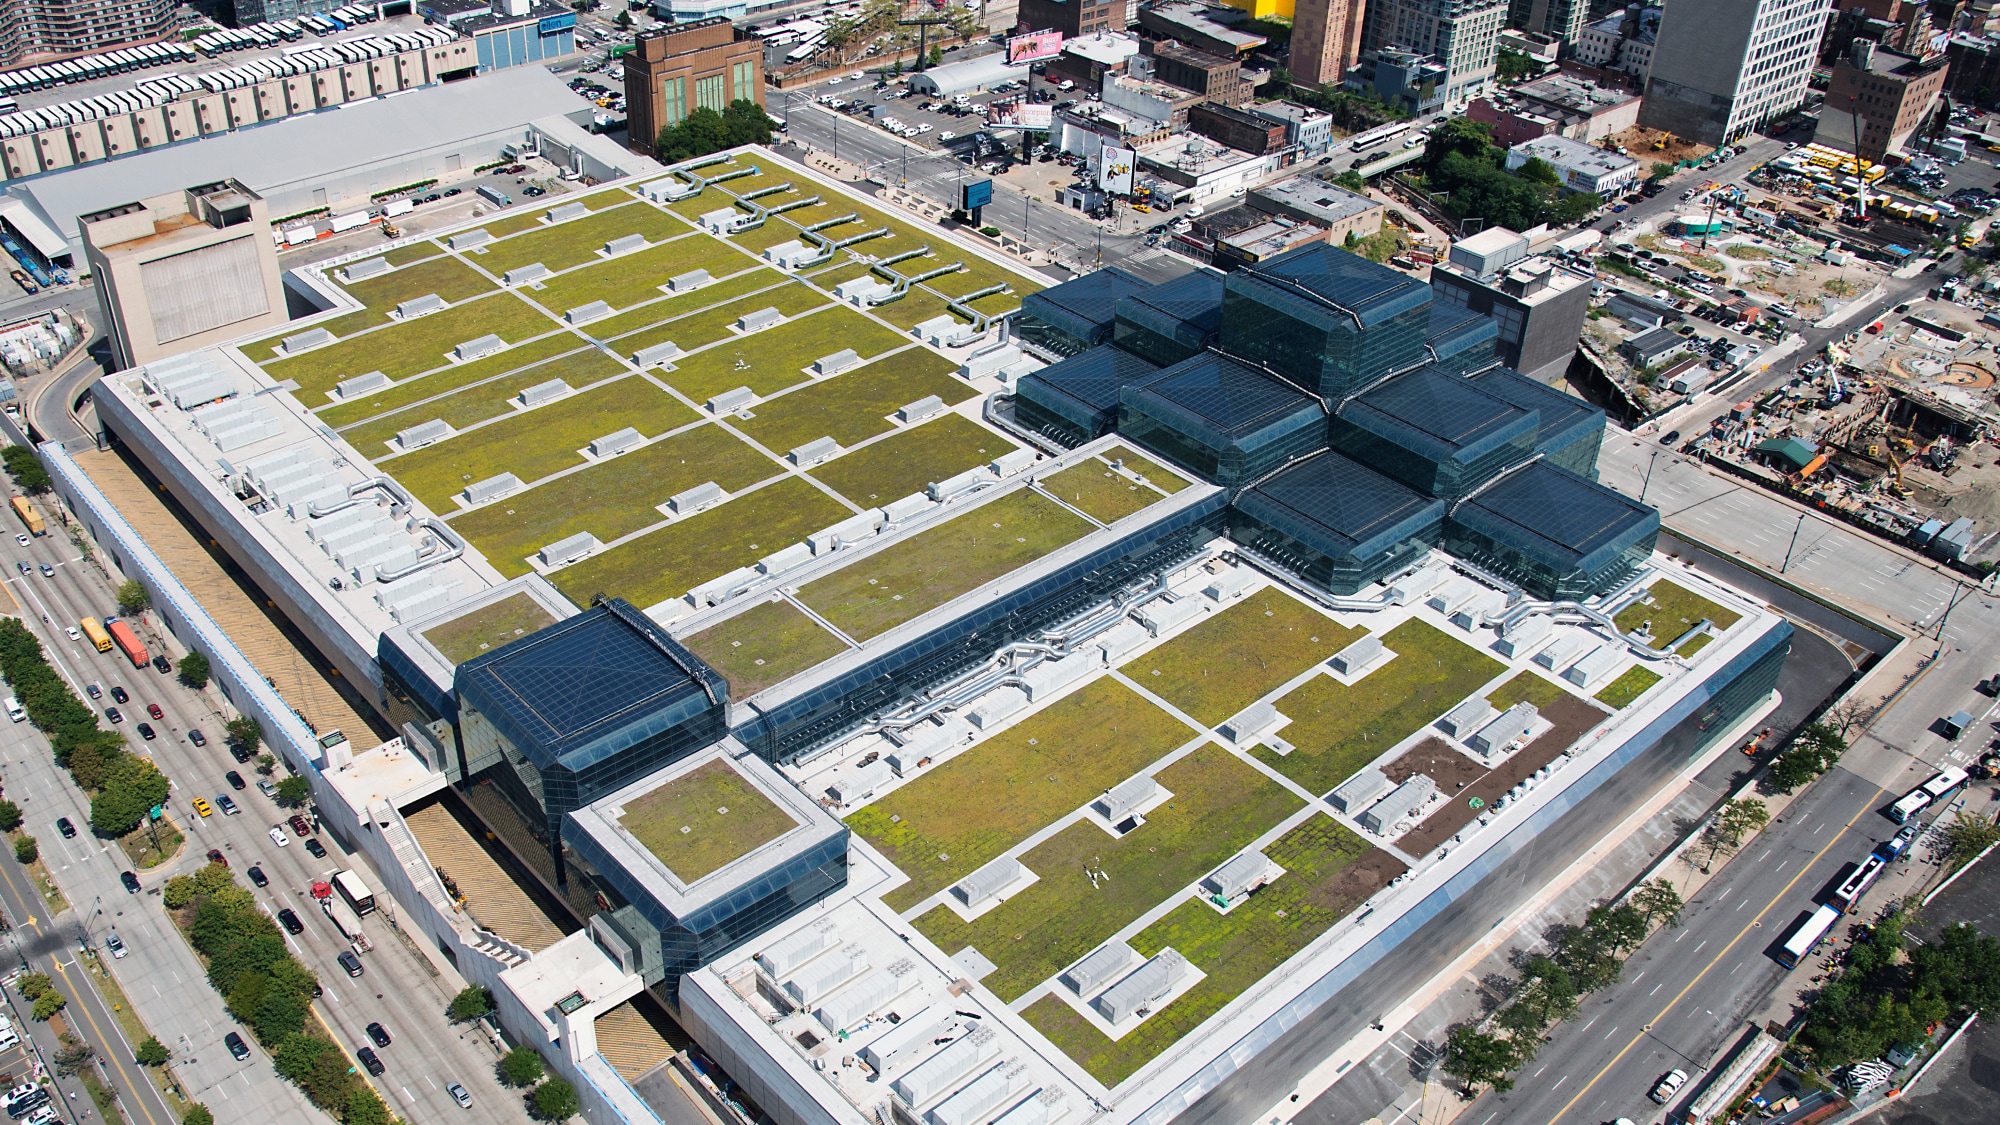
[{"x1": 0, "y1": 504, "x2": 518, "y2": 1125}]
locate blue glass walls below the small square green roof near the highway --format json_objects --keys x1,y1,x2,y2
[{"x1": 570, "y1": 808, "x2": 848, "y2": 1009}]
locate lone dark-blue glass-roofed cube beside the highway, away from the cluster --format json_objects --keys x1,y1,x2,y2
[{"x1": 454, "y1": 599, "x2": 728, "y2": 877}]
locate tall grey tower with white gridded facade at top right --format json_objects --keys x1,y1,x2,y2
[{"x1": 1638, "y1": 0, "x2": 1826, "y2": 144}]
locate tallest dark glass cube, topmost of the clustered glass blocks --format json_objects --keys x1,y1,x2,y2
[{"x1": 1222, "y1": 242, "x2": 1430, "y2": 402}]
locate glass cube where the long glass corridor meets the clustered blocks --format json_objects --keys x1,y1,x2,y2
[{"x1": 1230, "y1": 450, "x2": 1444, "y2": 595}]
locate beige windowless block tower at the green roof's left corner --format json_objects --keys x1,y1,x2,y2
[{"x1": 78, "y1": 180, "x2": 286, "y2": 370}]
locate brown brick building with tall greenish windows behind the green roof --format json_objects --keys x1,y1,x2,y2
[{"x1": 624, "y1": 16, "x2": 764, "y2": 152}]
